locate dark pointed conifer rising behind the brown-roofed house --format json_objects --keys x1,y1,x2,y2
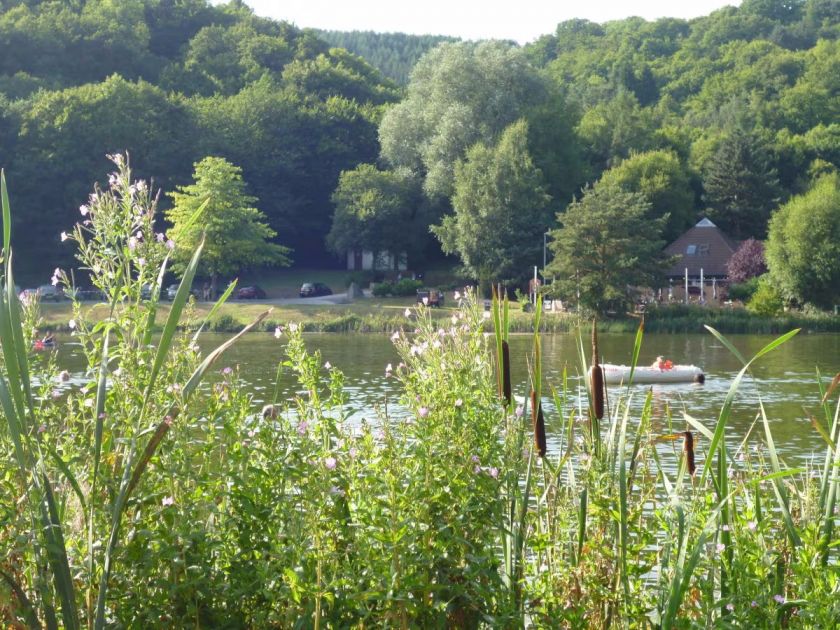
[{"x1": 703, "y1": 129, "x2": 781, "y2": 239}]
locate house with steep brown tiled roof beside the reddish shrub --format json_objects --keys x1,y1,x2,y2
[{"x1": 665, "y1": 219, "x2": 738, "y2": 302}]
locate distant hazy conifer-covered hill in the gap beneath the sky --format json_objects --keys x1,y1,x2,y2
[{"x1": 315, "y1": 30, "x2": 457, "y2": 85}]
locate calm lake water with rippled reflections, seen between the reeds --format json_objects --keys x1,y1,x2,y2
[{"x1": 59, "y1": 333, "x2": 840, "y2": 464}]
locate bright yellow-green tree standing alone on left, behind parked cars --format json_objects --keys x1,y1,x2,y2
[{"x1": 166, "y1": 157, "x2": 289, "y2": 295}]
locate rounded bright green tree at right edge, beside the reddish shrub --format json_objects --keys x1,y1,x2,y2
[{"x1": 765, "y1": 173, "x2": 840, "y2": 308}]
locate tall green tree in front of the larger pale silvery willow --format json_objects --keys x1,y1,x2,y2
[{"x1": 432, "y1": 121, "x2": 551, "y2": 291}]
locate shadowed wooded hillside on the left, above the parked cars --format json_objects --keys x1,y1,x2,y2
[{"x1": 0, "y1": 0, "x2": 397, "y2": 274}]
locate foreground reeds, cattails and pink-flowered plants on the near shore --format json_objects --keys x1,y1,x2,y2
[{"x1": 0, "y1": 158, "x2": 840, "y2": 629}]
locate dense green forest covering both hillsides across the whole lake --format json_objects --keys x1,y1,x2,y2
[{"x1": 0, "y1": 0, "x2": 840, "y2": 308}]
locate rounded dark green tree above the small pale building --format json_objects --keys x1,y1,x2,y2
[{"x1": 327, "y1": 164, "x2": 427, "y2": 264}]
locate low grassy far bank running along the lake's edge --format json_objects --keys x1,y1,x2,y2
[{"x1": 36, "y1": 298, "x2": 840, "y2": 334}]
